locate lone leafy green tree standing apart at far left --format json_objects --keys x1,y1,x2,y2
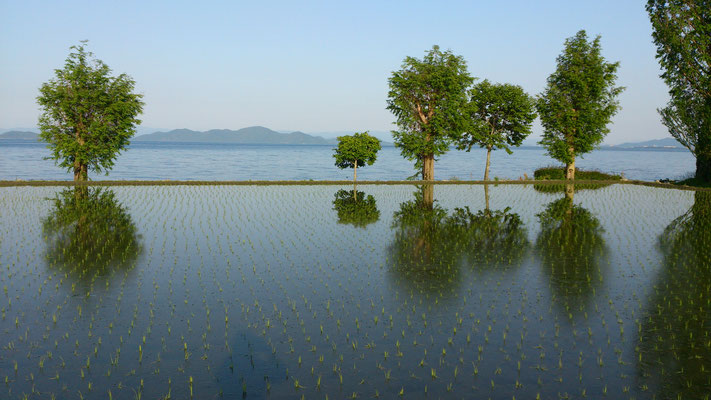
[{"x1": 37, "y1": 41, "x2": 144, "y2": 181}]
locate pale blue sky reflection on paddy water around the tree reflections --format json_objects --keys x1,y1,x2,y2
[{"x1": 0, "y1": 185, "x2": 694, "y2": 398}]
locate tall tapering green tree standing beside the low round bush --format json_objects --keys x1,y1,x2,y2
[{"x1": 536, "y1": 30, "x2": 624, "y2": 179}]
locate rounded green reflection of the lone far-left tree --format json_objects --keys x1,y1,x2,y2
[{"x1": 42, "y1": 187, "x2": 142, "y2": 282}]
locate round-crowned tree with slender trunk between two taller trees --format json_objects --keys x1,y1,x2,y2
[{"x1": 457, "y1": 80, "x2": 536, "y2": 181}]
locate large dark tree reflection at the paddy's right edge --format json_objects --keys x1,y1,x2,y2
[{"x1": 637, "y1": 192, "x2": 711, "y2": 399}]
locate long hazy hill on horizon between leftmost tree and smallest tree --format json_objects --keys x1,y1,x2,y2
[{"x1": 132, "y1": 126, "x2": 336, "y2": 144}]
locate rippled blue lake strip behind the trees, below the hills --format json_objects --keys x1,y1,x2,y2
[{"x1": 0, "y1": 140, "x2": 695, "y2": 181}]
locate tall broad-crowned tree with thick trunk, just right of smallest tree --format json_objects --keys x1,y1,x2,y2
[{"x1": 387, "y1": 46, "x2": 474, "y2": 181}]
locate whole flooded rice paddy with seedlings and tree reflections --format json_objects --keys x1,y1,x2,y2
[{"x1": 0, "y1": 185, "x2": 711, "y2": 399}]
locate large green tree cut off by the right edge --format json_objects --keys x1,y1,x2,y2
[{"x1": 646, "y1": 0, "x2": 711, "y2": 182}]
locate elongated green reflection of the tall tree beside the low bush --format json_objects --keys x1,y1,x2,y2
[{"x1": 536, "y1": 185, "x2": 607, "y2": 319}]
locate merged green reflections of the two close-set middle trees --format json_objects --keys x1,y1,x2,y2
[{"x1": 389, "y1": 185, "x2": 529, "y2": 292}]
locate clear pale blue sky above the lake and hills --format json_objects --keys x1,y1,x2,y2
[{"x1": 0, "y1": 0, "x2": 668, "y2": 144}]
